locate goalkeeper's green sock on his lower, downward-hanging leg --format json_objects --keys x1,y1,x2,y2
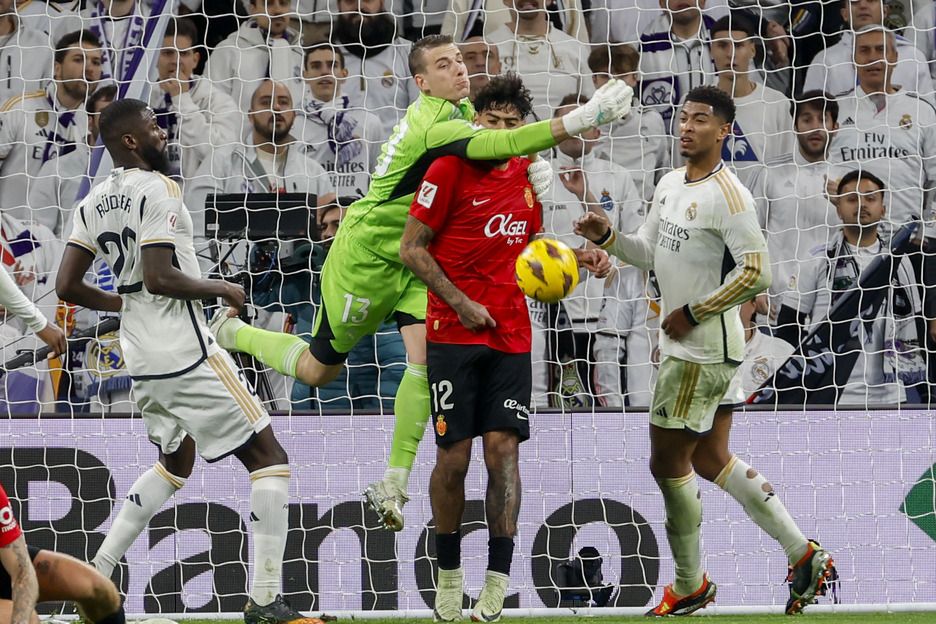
[{"x1": 384, "y1": 364, "x2": 429, "y2": 492}]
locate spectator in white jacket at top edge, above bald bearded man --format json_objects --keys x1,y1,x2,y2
[{"x1": 205, "y1": 0, "x2": 302, "y2": 116}]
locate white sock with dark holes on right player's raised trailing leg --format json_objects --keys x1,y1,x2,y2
[{"x1": 715, "y1": 456, "x2": 809, "y2": 563}]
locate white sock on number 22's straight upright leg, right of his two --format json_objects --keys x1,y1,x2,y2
[{"x1": 250, "y1": 464, "x2": 289, "y2": 606}]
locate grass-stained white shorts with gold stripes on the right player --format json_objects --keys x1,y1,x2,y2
[{"x1": 650, "y1": 357, "x2": 744, "y2": 433}]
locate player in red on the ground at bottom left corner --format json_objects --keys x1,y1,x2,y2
[{"x1": 0, "y1": 485, "x2": 126, "y2": 624}]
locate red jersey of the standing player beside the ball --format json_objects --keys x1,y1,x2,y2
[{"x1": 410, "y1": 156, "x2": 543, "y2": 353}]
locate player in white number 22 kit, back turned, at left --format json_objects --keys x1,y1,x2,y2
[{"x1": 55, "y1": 99, "x2": 314, "y2": 624}]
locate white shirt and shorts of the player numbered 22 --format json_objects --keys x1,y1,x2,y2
[{"x1": 68, "y1": 168, "x2": 270, "y2": 461}]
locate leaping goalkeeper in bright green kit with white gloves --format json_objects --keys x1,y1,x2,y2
[{"x1": 212, "y1": 35, "x2": 633, "y2": 531}]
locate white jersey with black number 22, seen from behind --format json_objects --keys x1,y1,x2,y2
[{"x1": 68, "y1": 168, "x2": 220, "y2": 380}]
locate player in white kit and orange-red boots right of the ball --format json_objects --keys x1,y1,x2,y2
[{"x1": 576, "y1": 87, "x2": 832, "y2": 616}]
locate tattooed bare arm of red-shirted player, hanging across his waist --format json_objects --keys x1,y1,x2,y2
[{"x1": 400, "y1": 216, "x2": 496, "y2": 331}]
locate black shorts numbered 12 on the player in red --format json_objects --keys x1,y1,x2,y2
[{"x1": 427, "y1": 342, "x2": 533, "y2": 446}]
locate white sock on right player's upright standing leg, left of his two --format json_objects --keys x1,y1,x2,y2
[{"x1": 657, "y1": 472, "x2": 704, "y2": 596}]
